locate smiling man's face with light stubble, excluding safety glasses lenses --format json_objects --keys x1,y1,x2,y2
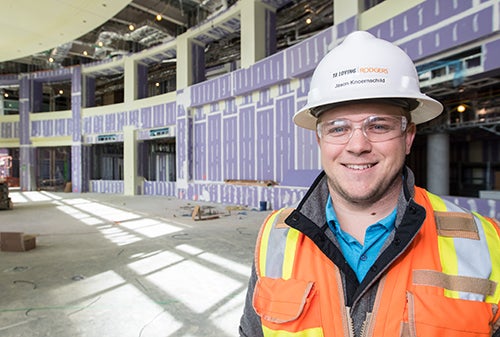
[{"x1": 317, "y1": 103, "x2": 416, "y2": 206}]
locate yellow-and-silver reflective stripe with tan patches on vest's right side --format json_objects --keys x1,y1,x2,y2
[{"x1": 427, "y1": 192, "x2": 500, "y2": 303}]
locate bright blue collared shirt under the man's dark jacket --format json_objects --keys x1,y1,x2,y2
[{"x1": 326, "y1": 198, "x2": 396, "y2": 282}]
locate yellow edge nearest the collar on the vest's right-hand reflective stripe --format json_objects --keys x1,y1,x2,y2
[{"x1": 427, "y1": 193, "x2": 460, "y2": 298}]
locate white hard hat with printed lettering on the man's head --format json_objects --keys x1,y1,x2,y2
[{"x1": 293, "y1": 31, "x2": 443, "y2": 130}]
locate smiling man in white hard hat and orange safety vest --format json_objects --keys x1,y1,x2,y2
[{"x1": 240, "y1": 32, "x2": 500, "y2": 337}]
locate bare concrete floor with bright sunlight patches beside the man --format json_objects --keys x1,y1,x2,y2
[{"x1": 0, "y1": 190, "x2": 269, "y2": 337}]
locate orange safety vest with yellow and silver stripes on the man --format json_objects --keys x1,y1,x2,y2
[{"x1": 253, "y1": 187, "x2": 500, "y2": 337}]
